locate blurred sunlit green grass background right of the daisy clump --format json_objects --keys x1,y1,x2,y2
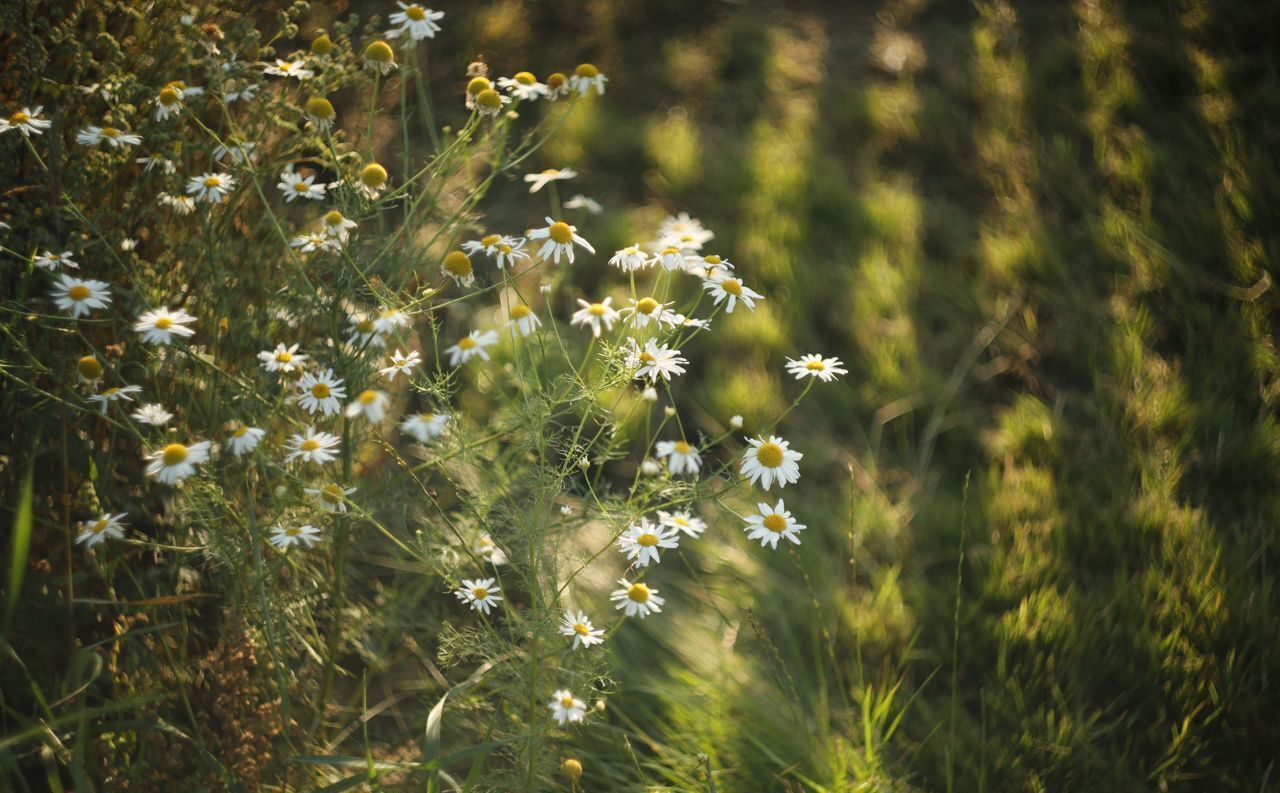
[{"x1": 422, "y1": 0, "x2": 1280, "y2": 790}]
